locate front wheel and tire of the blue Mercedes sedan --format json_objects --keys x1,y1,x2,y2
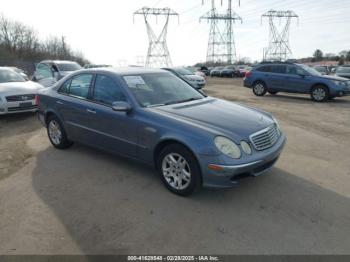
[{"x1": 157, "y1": 144, "x2": 202, "y2": 196}]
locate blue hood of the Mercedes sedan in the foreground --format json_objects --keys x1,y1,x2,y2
[{"x1": 154, "y1": 97, "x2": 274, "y2": 142}]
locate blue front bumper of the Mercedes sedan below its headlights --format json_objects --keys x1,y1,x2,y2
[{"x1": 202, "y1": 134, "x2": 287, "y2": 188}]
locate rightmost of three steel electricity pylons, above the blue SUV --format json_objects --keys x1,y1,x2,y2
[{"x1": 261, "y1": 10, "x2": 299, "y2": 61}]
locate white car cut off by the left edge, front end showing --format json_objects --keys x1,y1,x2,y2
[{"x1": 0, "y1": 67, "x2": 43, "y2": 115}]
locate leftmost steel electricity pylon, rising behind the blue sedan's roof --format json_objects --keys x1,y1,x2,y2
[{"x1": 134, "y1": 7, "x2": 179, "y2": 67}]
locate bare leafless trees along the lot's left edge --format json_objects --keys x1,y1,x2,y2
[{"x1": 0, "y1": 14, "x2": 89, "y2": 65}]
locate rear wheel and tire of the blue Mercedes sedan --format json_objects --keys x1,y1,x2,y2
[{"x1": 47, "y1": 115, "x2": 73, "y2": 149}]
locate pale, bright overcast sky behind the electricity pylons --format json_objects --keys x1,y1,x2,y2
[{"x1": 0, "y1": 0, "x2": 350, "y2": 66}]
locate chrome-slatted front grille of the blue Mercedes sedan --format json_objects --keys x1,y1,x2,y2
[{"x1": 250, "y1": 124, "x2": 281, "y2": 151}]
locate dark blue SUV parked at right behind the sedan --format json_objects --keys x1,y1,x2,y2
[{"x1": 244, "y1": 63, "x2": 350, "y2": 102}]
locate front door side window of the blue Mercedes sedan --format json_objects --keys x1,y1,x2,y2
[{"x1": 93, "y1": 75, "x2": 126, "y2": 105}]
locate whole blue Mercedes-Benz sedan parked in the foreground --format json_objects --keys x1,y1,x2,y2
[{"x1": 37, "y1": 68, "x2": 286, "y2": 196}]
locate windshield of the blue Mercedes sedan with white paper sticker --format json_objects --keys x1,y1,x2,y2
[{"x1": 123, "y1": 73, "x2": 205, "y2": 107}]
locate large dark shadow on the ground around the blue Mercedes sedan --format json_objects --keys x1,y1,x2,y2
[{"x1": 32, "y1": 145, "x2": 350, "y2": 254}]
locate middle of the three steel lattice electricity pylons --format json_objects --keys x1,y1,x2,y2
[{"x1": 199, "y1": 0, "x2": 242, "y2": 64}]
